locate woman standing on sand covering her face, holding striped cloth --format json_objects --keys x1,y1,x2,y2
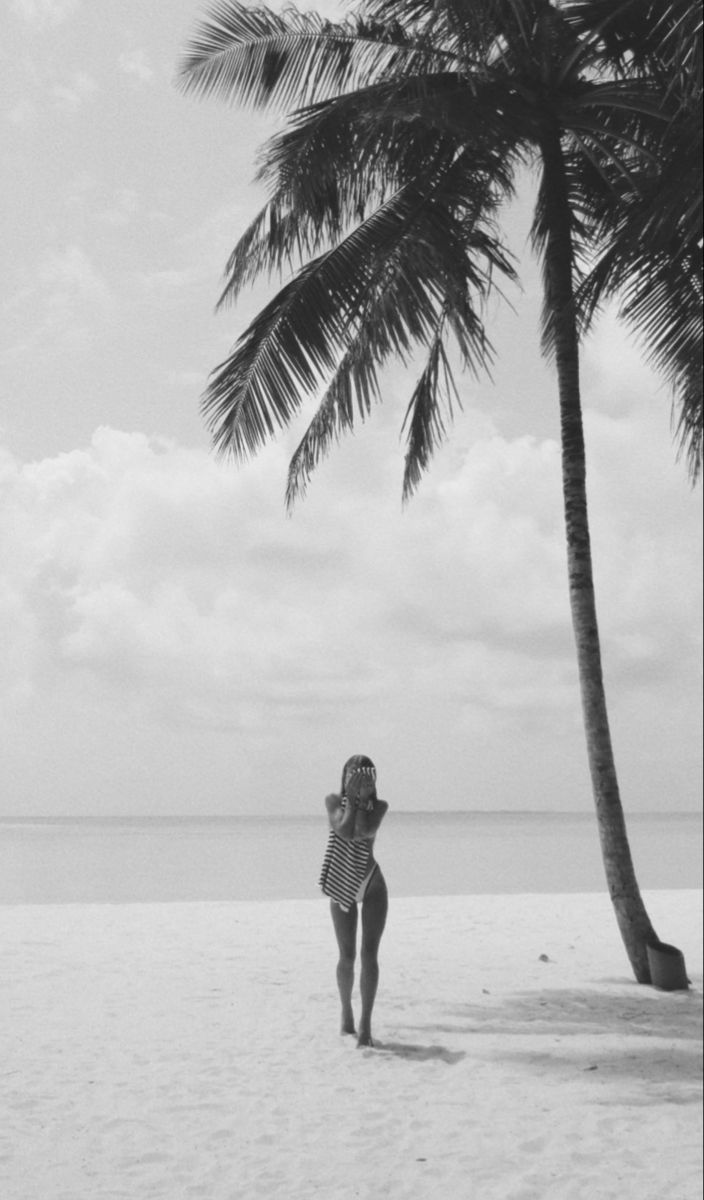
[{"x1": 320, "y1": 754, "x2": 389, "y2": 1046}]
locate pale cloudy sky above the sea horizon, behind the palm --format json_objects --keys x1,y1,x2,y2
[{"x1": 0, "y1": 0, "x2": 702, "y2": 816}]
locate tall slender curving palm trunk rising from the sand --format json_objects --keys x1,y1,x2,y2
[{"x1": 542, "y1": 131, "x2": 657, "y2": 983}]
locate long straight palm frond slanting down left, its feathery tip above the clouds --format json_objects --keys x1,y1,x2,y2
[{"x1": 203, "y1": 154, "x2": 512, "y2": 457}]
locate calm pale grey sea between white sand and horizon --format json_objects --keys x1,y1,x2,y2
[{"x1": 0, "y1": 811, "x2": 703, "y2": 905}]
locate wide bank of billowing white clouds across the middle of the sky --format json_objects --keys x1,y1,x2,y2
[{"x1": 4, "y1": 408, "x2": 696, "y2": 724}]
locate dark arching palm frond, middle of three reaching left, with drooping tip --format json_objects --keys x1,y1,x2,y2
[{"x1": 219, "y1": 64, "x2": 521, "y2": 314}]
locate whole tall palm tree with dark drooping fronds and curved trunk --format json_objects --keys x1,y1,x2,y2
[{"x1": 181, "y1": 0, "x2": 700, "y2": 983}]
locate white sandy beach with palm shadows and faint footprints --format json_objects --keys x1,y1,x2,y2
[{"x1": 0, "y1": 890, "x2": 702, "y2": 1200}]
